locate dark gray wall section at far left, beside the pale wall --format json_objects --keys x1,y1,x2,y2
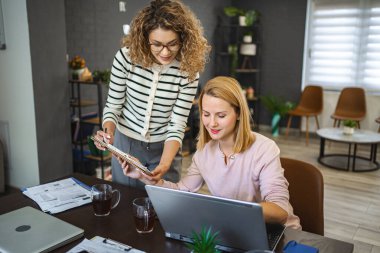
[{"x1": 25, "y1": 0, "x2": 73, "y2": 183}]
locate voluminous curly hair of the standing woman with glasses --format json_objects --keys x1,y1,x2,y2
[{"x1": 122, "y1": 0, "x2": 211, "y2": 80}]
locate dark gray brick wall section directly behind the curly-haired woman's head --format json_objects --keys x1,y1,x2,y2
[{"x1": 65, "y1": 0, "x2": 231, "y2": 84}]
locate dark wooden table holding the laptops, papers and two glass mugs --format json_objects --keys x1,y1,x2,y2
[{"x1": 0, "y1": 174, "x2": 353, "y2": 253}]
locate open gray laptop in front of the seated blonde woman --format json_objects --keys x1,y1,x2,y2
[{"x1": 145, "y1": 185, "x2": 285, "y2": 252}]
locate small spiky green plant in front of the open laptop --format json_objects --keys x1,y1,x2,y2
[{"x1": 186, "y1": 227, "x2": 220, "y2": 253}]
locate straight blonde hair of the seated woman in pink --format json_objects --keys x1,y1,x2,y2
[{"x1": 197, "y1": 76, "x2": 255, "y2": 153}]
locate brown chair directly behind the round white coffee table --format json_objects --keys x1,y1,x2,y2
[{"x1": 331, "y1": 87, "x2": 366, "y2": 129}]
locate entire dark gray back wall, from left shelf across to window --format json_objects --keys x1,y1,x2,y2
[{"x1": 65, "y1": 0, "x2": 307, "y2": 125}]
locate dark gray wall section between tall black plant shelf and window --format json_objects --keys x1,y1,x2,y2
[{"x1": 234, "y1": 0, "x2": 307, "y2": 125}]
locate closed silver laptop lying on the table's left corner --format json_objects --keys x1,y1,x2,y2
[{"x1": 0, "y1": 206, "x2": 84, "y2": 253}]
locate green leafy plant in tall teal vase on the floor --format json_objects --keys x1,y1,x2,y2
[{"x1": 260, "y1": 95, "x2": 295, "y2": 137}]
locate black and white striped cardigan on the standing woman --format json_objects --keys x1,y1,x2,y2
[{"x1": 103, "y1": 48, "x2": 199, "y2": 143}]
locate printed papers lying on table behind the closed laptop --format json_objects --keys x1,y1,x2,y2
[{"x1": 23, "y1": 178, "x2": 91, "y2": 213}]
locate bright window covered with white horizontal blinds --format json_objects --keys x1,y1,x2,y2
[{"x1": 303, "y1": 0, "x2": 380, "y2": 92}]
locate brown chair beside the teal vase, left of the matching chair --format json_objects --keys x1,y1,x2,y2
[{"x1": 286, "y1": 85, "x2": 323, "y2": 145}]
